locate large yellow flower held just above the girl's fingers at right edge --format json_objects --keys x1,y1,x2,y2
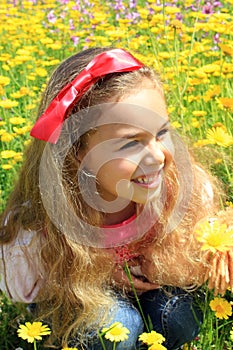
[{"x1": 196, "y1": 220, "x2": 233, "y2": 253}]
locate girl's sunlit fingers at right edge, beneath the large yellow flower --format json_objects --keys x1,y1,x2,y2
[{"x1": 206, "y1": 248, "x2": 233, "y2": 295}]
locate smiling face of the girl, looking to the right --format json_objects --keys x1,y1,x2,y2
[{"x1": 81, "y1": 86, "x2": 173, "y2": 208}]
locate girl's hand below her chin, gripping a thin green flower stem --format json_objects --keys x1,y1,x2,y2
[{"x1": 112, "y1": 263, "x2": 160, "y2": 293}]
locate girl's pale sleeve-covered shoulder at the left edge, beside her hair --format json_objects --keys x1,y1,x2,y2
[{"x1": 0, "y1": 229, "x2": 44, "y2": 303}]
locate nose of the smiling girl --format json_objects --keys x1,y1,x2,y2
[{"x1": 143, "y1": 140, "x2": 165, "y2": 165}]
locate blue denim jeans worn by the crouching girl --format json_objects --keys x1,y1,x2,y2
[{"x1": 70, "y1": 288, "x2": 203, "y2": 350}]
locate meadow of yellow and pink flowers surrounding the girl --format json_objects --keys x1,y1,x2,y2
[{"x1": 0, "y1": 0, "x2": 233, "y2": 350}]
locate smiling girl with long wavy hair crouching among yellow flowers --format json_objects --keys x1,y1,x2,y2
[{"x1": 0, "y1": 48, "x2": 230, "y2": 350}]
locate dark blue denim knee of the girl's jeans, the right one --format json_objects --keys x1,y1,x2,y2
[{"x1": 140, "y1": 288, "x2": 203, "y2": 350}]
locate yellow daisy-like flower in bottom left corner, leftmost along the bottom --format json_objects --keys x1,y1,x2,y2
[{"x1": 17, "y1": 322, "x2": 51, "y2": 343}]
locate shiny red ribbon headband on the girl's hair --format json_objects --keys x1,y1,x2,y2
[{"x1": 30, "y1": 49, "x2": 144, "y2": 143}]
